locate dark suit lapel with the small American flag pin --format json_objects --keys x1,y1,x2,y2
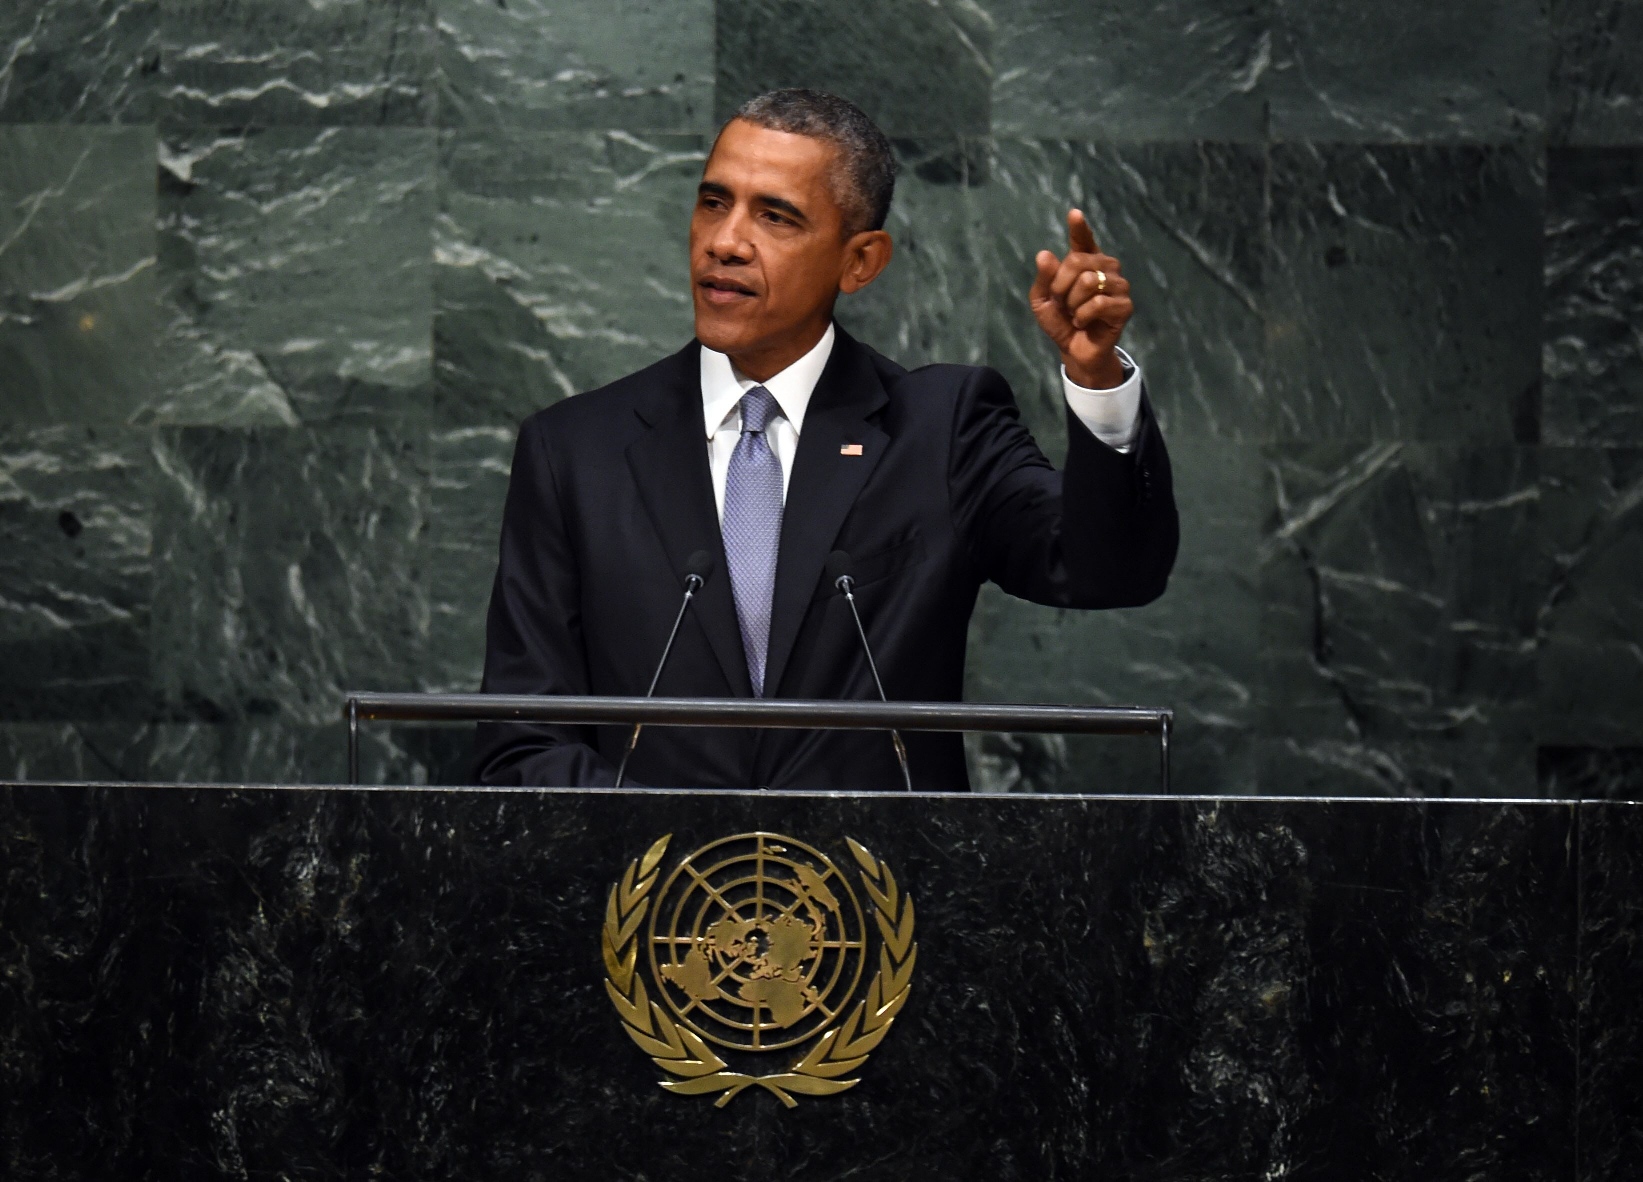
[{"x1": 764, "y1": 329, "x2": 891, "y2": 697}]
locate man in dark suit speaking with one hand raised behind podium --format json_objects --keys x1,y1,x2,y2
[{"x1": 476, "y1": 90, "x2": 1178, "y2": 789}]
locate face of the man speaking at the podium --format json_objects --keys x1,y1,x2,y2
[{"x1": 690, "y1": 120, "x2": 877, "y2": 368}]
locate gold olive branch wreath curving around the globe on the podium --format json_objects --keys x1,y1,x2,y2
[{"x1": 600, "y1": 833, "x2": 918, "y2": 1108}]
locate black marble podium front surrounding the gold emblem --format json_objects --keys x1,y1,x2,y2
[{"x1": 0, "y1": 784, "x2": 1643, "y2": 1182}]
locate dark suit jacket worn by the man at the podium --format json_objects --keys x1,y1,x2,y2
[{"x1": 476, "y1": 323, "x2": 1178, "y2": 789}]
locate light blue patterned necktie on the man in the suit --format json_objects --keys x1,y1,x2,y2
[{"x1": 723, "y1": 386, "x2": 782, "y2": 697}]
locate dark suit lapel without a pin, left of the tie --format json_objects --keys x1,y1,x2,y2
[{"x1": 628, "y1": 344, "x2": 752, "y2": 697}]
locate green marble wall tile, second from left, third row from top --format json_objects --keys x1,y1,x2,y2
[{"x1": 154, "y1": 427, "x2": 429, "y2": 727}]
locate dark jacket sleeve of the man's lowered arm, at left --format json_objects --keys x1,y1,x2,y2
[{"x1": 473, "y1": 418, "x2": 616, "y2": 787}]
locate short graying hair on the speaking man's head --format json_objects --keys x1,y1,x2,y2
[{"x1": 731, "y1": 87, "x2": 895, "y2": 233}]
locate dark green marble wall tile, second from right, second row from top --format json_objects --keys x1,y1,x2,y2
[{"x1": 1267, "y1": 145, "x2": 1544, "y2": 444}]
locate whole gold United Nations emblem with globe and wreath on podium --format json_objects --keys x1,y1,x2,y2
[{"x1": 600, "y1": 833, "x2": 918, "y2": 1108}]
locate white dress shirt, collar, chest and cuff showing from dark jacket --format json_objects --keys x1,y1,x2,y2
[{"x1": 702, "y1": 324, "x2": 1140, "y2": 521}]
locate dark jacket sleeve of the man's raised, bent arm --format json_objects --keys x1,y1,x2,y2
[{"x1": 950, "y1": 368, "x2": 1180, "y2": 608}]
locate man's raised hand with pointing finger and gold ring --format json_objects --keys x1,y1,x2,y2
[{"x1": 1027, "y1": 209, "x2": 1135, "y2": 390}]
